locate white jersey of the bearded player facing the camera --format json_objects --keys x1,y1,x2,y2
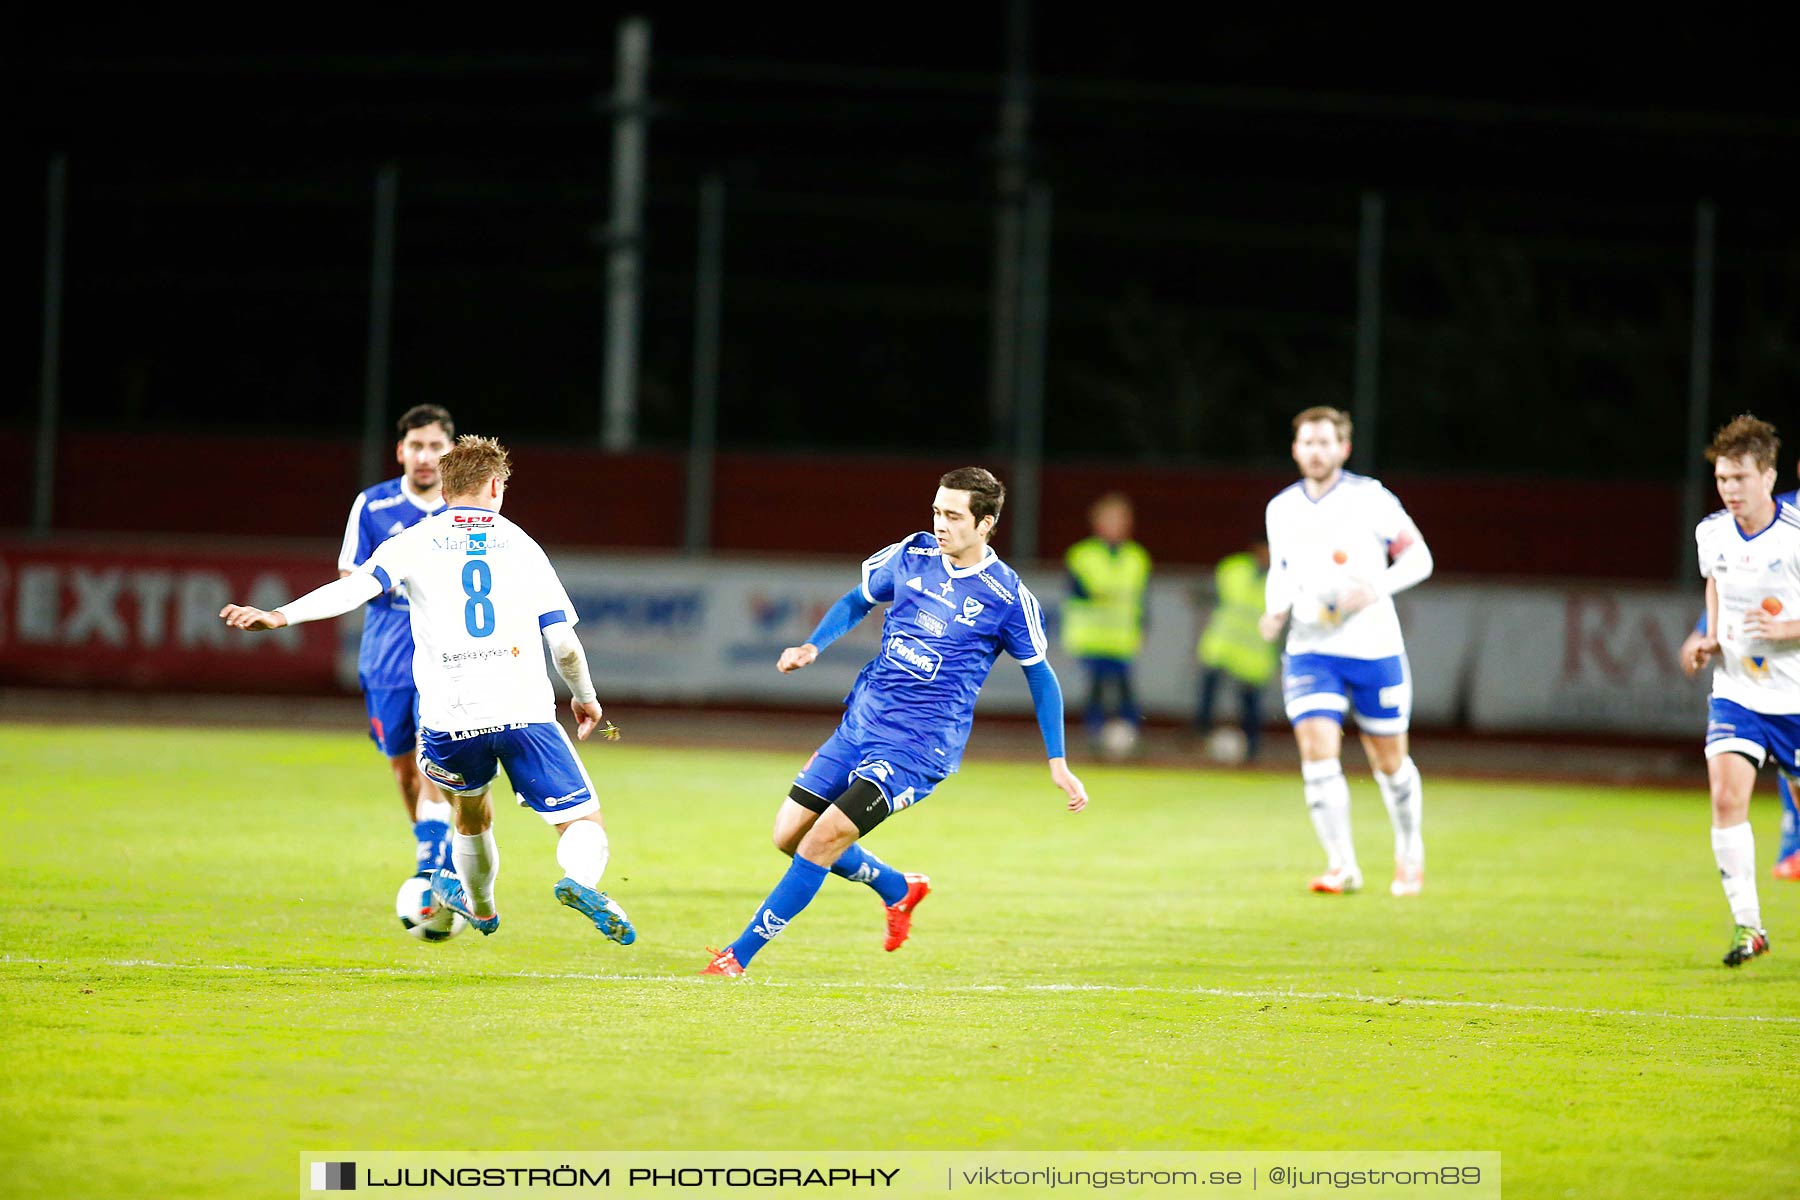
[{"x1": 1265, "y1": 471, "x2": 1418, "y2": 658}]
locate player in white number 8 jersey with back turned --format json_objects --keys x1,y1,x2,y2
[{"x1": 220, "y1": 437, "x2": 637, "y2": 945}]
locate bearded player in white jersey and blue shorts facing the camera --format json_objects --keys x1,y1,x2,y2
[{"x1": 1258, "y1": 407, "x2": 1431, "y2": 896}]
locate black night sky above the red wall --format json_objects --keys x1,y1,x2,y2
[{"x1": 7, "y1": 5, "x2": 1800, "y2": 477}]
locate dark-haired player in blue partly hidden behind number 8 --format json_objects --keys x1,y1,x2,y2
[{"x1": 338, "y1": 405, "x2": 455, "y2": 874}]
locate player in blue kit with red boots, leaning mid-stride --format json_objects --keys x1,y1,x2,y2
[{"x1": 700, "y1": 466, "x2": 1087, "y2": 975}]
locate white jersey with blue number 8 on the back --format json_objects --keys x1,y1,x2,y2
[{"x1": 358, "y1": 506, "x2": 576, "y2": 732}]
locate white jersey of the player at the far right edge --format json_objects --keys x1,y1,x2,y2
[{"x1": 1694, "y1": 500, "x2": 1800, "y2": 714}]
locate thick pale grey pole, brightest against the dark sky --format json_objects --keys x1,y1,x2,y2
[{"x1": 599, "y1": 16, "x2": 650, "y2": 452}]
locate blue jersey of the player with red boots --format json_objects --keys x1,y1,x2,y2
[{"x1": 842, "y1": 533, "x2": 1048, "y2": 772}]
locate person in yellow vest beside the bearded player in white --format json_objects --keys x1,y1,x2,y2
[{"x1": 1193, "y1": 542, "x2": 1282, "y2": 763}]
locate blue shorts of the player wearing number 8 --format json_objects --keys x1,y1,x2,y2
[{"x1": 419, "y1": 721, "x2": 599, "y2": 826}]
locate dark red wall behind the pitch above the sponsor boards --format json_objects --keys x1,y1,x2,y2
[{"x1": 0, "y1": 432, "x2": 1687, "y2": 581}]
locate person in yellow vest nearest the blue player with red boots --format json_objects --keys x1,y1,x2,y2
[{"x1": 1062, "y1": 493, "x2": 1150, "y2": 757}]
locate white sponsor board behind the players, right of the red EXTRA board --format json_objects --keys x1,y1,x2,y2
[{"x1": 525, "y1": 556, "x2": 1706, "y2": 736}]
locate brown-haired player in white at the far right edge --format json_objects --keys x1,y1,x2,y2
[{"x1": 1681, "y1": 414, "x2": 1800, "y2": 966}]
